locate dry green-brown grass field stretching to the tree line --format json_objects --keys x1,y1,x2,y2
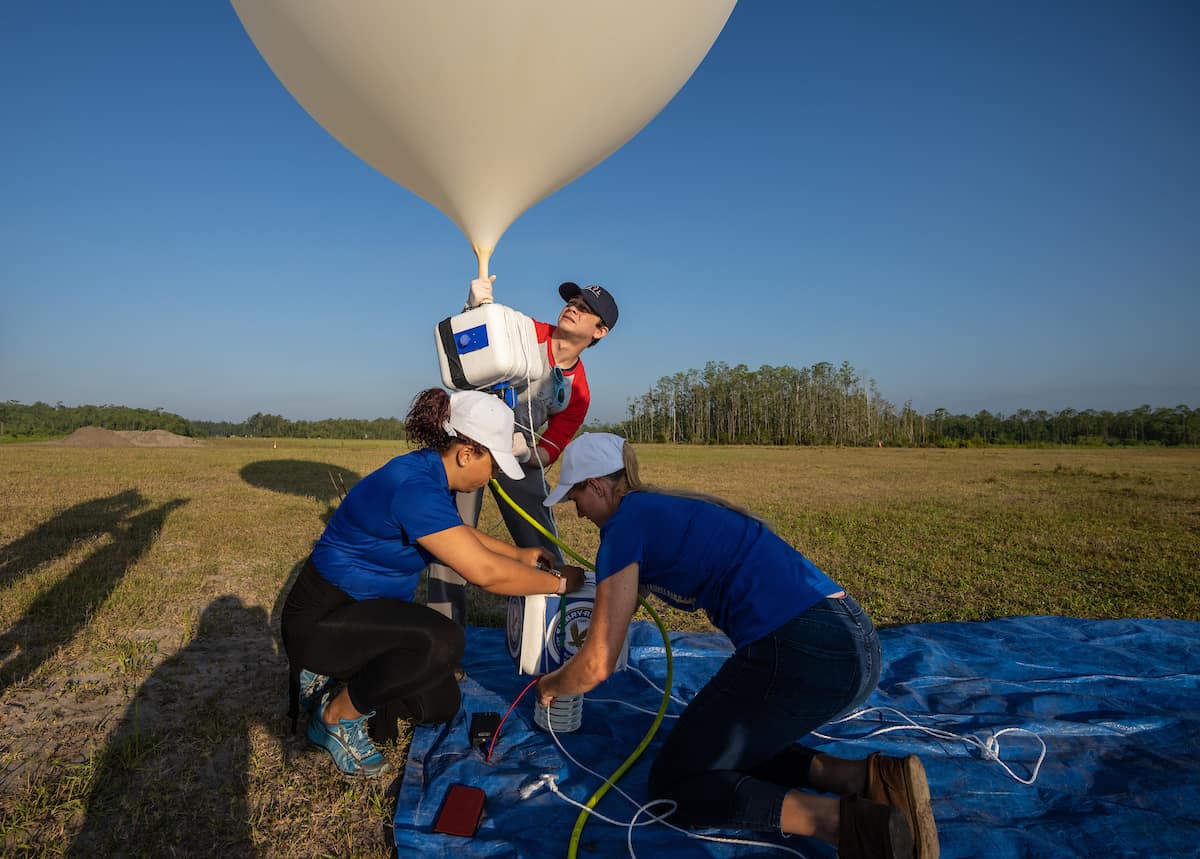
[{"x1": 0, "y1": 440, "x2": 1200, "y2": 855}]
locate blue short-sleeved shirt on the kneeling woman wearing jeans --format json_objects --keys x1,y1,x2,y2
[{"x1": 596, "y1": 492, "x2": 841, "y2": 648}]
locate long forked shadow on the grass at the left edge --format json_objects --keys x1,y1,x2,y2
[{"x1": 0, "y1": 489, "x2": 187, "y2": 695}]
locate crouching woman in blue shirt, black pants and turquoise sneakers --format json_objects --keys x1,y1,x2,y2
[{"x1": 282, "y1": 389, "x2": 583, "y2": 776}]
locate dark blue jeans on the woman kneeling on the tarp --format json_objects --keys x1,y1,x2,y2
[{"x1": 649, "y1": 596, "x2": 882, "y2": 834}]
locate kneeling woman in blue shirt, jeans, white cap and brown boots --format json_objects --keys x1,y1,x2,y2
[{"x1": 538, "y1": 433, "x2": 938, "y2": 859}]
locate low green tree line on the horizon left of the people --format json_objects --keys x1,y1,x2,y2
[{"x1": 0, "y1": 400, "x2": 404, "y2": 440}]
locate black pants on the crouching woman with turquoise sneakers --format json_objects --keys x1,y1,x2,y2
[{"x1": 281, "y1": 558, "x2": 464, "y2": 741}]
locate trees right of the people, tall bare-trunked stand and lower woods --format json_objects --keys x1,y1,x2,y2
[{"x1": 594, "y1": 361, "x2": 1200, "y2": 447}]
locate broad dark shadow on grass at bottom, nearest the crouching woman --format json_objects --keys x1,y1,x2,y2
[{"x1": 67, "y1": 595, "x2": 276, "y2": 855}]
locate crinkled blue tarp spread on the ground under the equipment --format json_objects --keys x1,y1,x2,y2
[{"x1": 395, "y1": 617, "x2": 1200, "y2": 859}]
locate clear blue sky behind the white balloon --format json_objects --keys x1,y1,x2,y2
[{"x1": 0, "y1": 0, "x2": 1200, "y2": 420}]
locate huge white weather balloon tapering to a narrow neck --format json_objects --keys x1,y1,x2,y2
[{"x1": 233, "y1": 0, "x2": 736, "y2": 276}]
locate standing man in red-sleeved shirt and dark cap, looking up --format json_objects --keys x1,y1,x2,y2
[{"x1": 426, "y1": 276, "x2": 617, "y2": 626}]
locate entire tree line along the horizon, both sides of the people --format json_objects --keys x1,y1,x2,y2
[{"x1": 0, "y1": 361, "x2": 1200, "y2": 447}]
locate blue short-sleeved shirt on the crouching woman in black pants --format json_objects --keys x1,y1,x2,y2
[{"x1": 312, "y1": 449, "x2": 462, "y2": 600}]
